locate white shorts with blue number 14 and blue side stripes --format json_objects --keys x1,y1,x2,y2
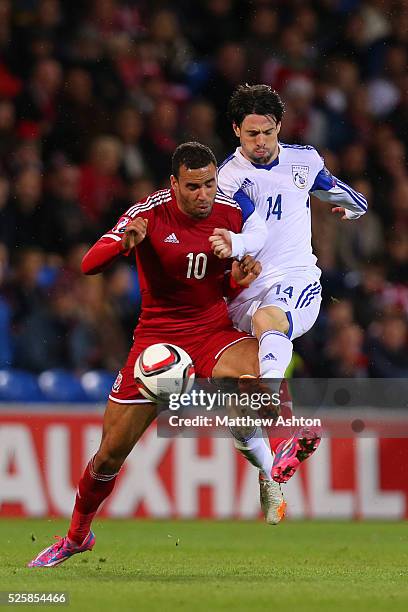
[{"x1": 228, "y1": 268, "x2": 322, "y2": 340}]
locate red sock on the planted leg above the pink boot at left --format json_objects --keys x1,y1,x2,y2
[{"x1": 68, "y1": 458, "x2": 117, "y2": 544}]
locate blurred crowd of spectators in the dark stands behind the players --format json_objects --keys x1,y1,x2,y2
[{"x1": 0, "y1": 0, "x2": 408, "y2": 377}]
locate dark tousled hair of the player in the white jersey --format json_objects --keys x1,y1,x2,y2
[{"x1": 228, "y1": 84, "x2": 285, "y2": 126}]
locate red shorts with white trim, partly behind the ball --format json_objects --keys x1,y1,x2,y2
[{"x1": 109, "y1": 326, "x2": 253, "y2": 404}]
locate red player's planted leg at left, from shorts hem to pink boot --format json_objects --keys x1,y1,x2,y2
[{"x1": 28, "y1": 400, "x2": 156, "y2": 567}]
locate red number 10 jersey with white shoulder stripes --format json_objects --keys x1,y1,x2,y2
[{"x1": 83, "y1": 189, "x2": 243, "y2": 334}]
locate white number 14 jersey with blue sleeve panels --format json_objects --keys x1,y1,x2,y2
[{"x1": 218, "y1": 143, "x2": 367, "y2": 280}]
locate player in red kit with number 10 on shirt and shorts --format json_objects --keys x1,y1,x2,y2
[{"x1": 29, "y1": 143, "x2": 285, "y2": 567}]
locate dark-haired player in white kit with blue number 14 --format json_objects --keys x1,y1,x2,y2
[{"x1": 212, "y1": 85, "x2": 367, "y2": 520}]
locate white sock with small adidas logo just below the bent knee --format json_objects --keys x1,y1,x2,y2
[{"x1": 259, "y1": 330, "x2": 293, "y2": 379}]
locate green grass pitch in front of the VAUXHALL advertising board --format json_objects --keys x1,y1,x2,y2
[{"x1": 0, "y1": 519, "x2": 408, "y2": 612}]
